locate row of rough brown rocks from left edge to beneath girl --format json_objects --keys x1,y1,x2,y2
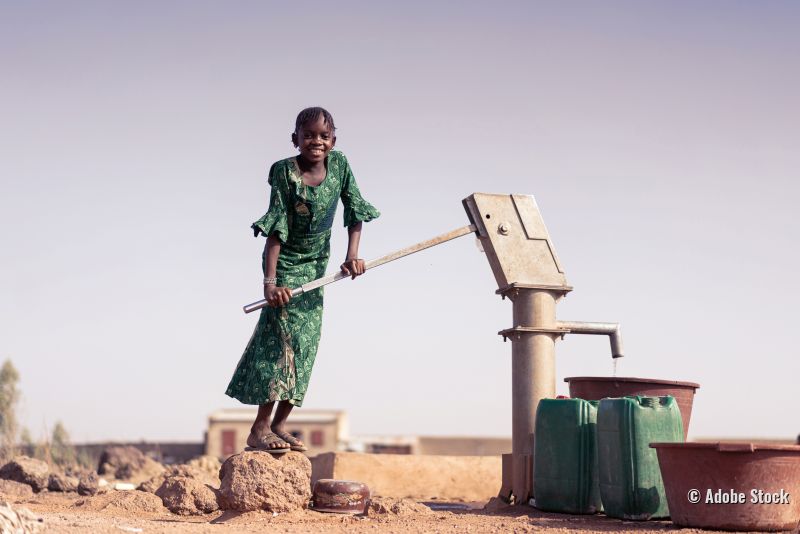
[{"x1": 0, "y1": 447, "x2": 320, "y2": 515}]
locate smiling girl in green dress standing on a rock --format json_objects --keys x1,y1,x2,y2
[{"x1": 225, "y1": 107, "x2": 380, "y2": 452}]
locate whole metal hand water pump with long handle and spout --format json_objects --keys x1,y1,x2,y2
[{"x1": 244, "y1": 193, "x2": 623, "y2": 503}]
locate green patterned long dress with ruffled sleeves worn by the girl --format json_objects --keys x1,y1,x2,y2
[{"x1": 225, "y1": 151, "x2": 380, "y2": 406}]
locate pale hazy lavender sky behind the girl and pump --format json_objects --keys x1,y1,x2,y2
[{"x1": 0, "y1": 0, "x2": 800, "y2": 441}]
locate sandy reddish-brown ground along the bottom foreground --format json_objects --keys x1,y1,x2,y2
[{"x1": 14, "y1": 492, "x2": 792, "y2": 534}]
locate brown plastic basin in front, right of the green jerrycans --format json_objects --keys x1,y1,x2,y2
[{"x1": 650, "y1": 443, "x2": 800, "y2": 531}]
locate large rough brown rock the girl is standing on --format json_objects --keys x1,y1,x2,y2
[{"x1": 219, "y1": 451, "x2": 311, "y2": 512}]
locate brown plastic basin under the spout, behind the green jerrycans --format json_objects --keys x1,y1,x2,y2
[{"x1": 564, "y1": 376, "x2": 700, "y2": 439}]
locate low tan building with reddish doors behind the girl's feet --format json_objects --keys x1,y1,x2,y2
[{"x1": 205, "y1": 408, "x2": 348, "y2": 459}]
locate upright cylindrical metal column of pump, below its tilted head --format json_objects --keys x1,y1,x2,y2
[{"x1": 498, "y1": 284, "x2": 569, "y2": 504}]
